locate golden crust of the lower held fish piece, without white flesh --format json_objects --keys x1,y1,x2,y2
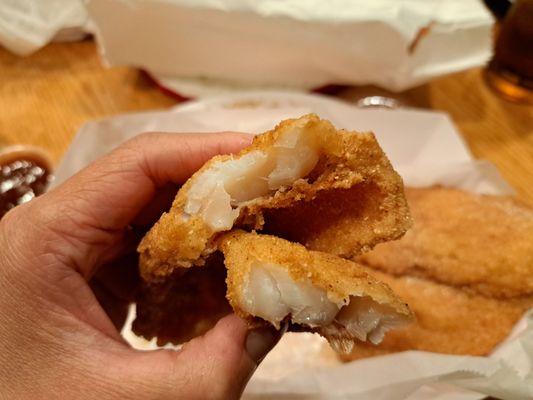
[{"x1": 219, "y1": 230, "x2": 412, "y2": 348}]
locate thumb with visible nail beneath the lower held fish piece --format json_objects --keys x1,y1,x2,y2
[{"x1": 128, "y1": 315, "x2": 282, "y2": 399}]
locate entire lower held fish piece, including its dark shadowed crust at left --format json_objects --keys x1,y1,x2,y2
[{"x1": 133, "y1": 231, "x2": 412, "y2": 353}]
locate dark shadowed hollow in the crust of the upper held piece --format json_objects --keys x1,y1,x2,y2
[{"x1": 264, "y1": 182, "x2": 404, "y2": 258}]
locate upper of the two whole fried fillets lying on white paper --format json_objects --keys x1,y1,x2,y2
[{"x1": 358, "y1": 188, "x2": 533, "y2": 299}]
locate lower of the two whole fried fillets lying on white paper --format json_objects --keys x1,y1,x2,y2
[{"x1": 342, "y1": 270, "x2": 533, "y2": 361}]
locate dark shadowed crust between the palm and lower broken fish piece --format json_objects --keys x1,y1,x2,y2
[{"x1": 132, "y1": 254, "x2": 231, "y2": 346}]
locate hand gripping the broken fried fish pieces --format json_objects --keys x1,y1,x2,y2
[{"x1": 0, "y1": 133, "x2": 279, "y2": 399}]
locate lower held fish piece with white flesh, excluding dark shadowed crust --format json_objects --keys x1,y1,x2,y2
[{"x1": 219, "y1": 231, "x2": 412, "y2": 353}]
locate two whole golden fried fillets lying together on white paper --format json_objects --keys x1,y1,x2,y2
[{"x1": 345, "y1": 187, "x2": 533, "y2": 360}]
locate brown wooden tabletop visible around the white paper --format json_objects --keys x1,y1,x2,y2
[{"x1": 0, "y1": 40, "x2": 533, "y2": 203}]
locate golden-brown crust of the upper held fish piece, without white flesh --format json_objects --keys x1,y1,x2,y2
[{"x1": 138, "y1": 114, "x2": 411, "y2": 281}]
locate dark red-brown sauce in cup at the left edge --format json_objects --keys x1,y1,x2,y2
[{"x1": 0, "y1": 158, "x2": 52, "y2": 218}]
